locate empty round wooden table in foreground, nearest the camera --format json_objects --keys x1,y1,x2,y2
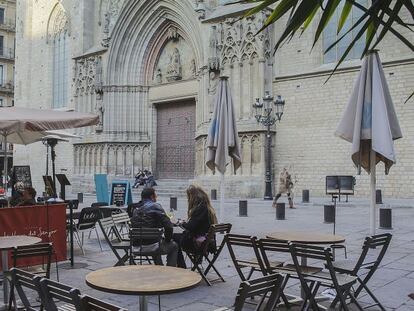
[{"x1": 86, "y1": 265, "x2": 201, "y2": 311}]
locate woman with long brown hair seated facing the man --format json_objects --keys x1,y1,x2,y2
[{"x1": 173, "y1": 185, "x2": 217, "y2": 268}]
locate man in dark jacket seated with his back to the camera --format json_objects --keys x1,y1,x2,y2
[{"x1": 131, "y1": 188, "x2": 178, "y2": 267}]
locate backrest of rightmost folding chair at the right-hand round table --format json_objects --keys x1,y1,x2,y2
[{"x1": 354, "y1": 233, "x2": 392, "y2": 273}]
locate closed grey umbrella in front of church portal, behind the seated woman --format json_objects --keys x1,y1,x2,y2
[{"x1": 206, "y1": 77, "x2": 241, "y2": 222}]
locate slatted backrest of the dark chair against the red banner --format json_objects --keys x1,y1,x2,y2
[{"x1": 12, "y1": 242, "x2": 53, "y2": 278}]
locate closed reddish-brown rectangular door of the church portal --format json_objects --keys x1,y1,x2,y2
[{"x1": 156, "y1": 99, "x2": 196, "y2": 179}]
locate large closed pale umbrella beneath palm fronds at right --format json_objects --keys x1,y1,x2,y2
[{"x1": 335, "y1": 51, "x2": 402, "y2": 234}]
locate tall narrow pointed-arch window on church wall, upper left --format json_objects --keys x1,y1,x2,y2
[{"x1": 48, "y1": 4, "x2": 69, "y2": 108}]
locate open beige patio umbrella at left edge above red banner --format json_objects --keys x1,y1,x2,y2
[{"x1": 0, "y1": 107, "x2": 99, "y2": 195}]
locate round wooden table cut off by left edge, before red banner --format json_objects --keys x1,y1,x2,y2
[{"x1": 0, "y1": 235, "x2": 42, "y2": 310}]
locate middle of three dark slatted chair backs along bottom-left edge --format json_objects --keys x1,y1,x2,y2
[{"x1": 40, "y1": 278, "x2": 81, "y2": 311}]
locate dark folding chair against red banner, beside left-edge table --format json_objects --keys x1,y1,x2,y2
[{"x1": 5, "y1": 243, "x2": 53, "y2": 307}]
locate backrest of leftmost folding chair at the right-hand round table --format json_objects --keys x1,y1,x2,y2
[{"x1": 225, "y1": 233, "x2": 265, "y2": 281}]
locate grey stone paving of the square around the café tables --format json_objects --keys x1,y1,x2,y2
[{"x1": 48, "y1": 196, "x2": 414, "y2": 311}]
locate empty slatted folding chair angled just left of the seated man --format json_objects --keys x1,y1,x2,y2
[{"x1": 98, "y1": 217, "x2": 130, "y2": 267}]
